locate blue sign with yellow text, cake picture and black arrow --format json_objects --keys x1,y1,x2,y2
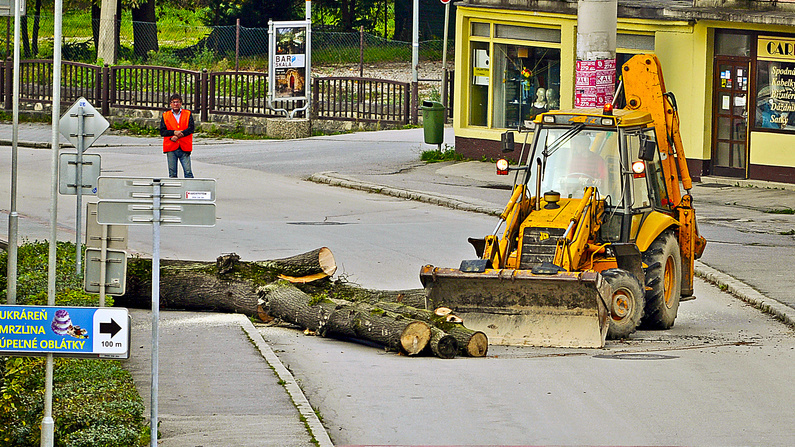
[{"x1": 0, "y1": 305, "x2": 130, "y2": 359}]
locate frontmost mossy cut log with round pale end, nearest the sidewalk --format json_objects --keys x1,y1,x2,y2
[{"x1": 258, "y1": 281, "x2": 431, "y2": 355}]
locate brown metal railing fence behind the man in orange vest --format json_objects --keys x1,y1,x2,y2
[{"x1": 0, "y1": 59, "x2": 422, "y2": 124}]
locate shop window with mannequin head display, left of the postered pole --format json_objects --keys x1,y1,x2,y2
[{"x1": 492, "y1": 44, "x2": 560, "y2": 128}]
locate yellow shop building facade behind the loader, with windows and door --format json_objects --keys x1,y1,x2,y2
[{"x1": 453, "y1": 0, "x2": 795, "y2": 183}]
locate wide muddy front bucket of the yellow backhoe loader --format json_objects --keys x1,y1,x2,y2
[{"x1": 420, "y1": 265, "x2": 612, "y2": 348}]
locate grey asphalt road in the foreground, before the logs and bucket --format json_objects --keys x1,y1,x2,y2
[{"x1": 259, "y1": 281, "x2": 795, "y2": 446}]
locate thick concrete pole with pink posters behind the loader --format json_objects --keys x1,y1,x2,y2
[{"x1": 574, "y1": 0, "x2": 618, "y2": 107}]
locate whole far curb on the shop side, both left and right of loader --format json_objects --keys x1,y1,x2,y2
[{"x1": 307, "y1": 172, "x2": 795, "y2": 327}]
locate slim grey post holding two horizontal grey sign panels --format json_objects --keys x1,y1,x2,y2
[{"x1": 150, "y1": 179, "x2": 161, "y2": 447}]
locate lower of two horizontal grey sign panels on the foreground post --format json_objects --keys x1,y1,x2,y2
[{"x1": 97, "y1": 200, "x2": 215, "y2": 227}]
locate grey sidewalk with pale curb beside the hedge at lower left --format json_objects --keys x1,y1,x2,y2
[{"x1": 124, "y1": 309, "x2": 333, "y2": 447}]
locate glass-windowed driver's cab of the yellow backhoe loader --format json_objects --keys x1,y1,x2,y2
[{"x1": 527, "y1": 115, "x2": 671, "y2": 247}]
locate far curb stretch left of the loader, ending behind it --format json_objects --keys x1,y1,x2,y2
[{"x1": 307, "y1": 172, "x2": 502, "y2": 216}]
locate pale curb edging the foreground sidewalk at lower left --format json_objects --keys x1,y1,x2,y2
[{"x1": 236, "y1": 314, "x2": 334, "y2": 447}]
